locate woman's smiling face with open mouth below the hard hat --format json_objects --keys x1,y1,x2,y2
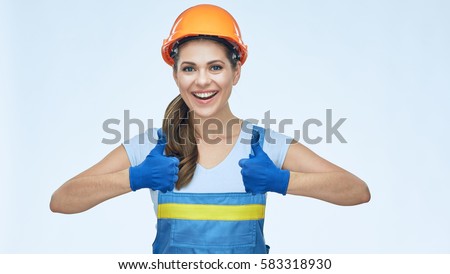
[{"x1": 174, "y1": 40, "x2": 240, "y2": 119}]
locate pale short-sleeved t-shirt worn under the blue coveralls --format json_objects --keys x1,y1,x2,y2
[{"x1": 123, "y1": 123, "x2": 292, "y2": 213}]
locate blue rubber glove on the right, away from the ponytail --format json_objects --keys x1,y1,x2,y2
[{"x1": 239, "y1": 133, "x2": 290, "y2": 195}]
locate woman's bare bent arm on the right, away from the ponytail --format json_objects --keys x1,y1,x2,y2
[{"x1": 283, "y1": 142, "x2": 370, "y2": 205}]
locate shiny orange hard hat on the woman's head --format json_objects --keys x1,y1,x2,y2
[{"x1": 161, "y1": 4, "x2": 247, "y2": 66}]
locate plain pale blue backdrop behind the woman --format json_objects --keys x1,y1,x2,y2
[{"x1": 0, "y1": 0, "x2": 450, "y2": 253}]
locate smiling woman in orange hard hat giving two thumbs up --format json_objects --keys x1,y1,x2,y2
[{"x1": 50, "y1": 5, "x2": 370, "y2": 253}]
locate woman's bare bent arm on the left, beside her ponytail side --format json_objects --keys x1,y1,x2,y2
[{"x1": 50, "y1": 145, "x2": 131, "y2": 213}]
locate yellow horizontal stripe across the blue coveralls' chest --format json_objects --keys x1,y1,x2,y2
[{"x1": 158, "y1": 203, "x2": 266, "y2": 221}]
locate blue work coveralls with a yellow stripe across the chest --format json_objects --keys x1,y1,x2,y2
[{"x1": 153, "y1": 126, "x2": 269, "y2": 254}]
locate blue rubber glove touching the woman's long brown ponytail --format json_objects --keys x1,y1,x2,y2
[{"x1": 129, "y1": 131, "x2": 180, "y2": 192}]
